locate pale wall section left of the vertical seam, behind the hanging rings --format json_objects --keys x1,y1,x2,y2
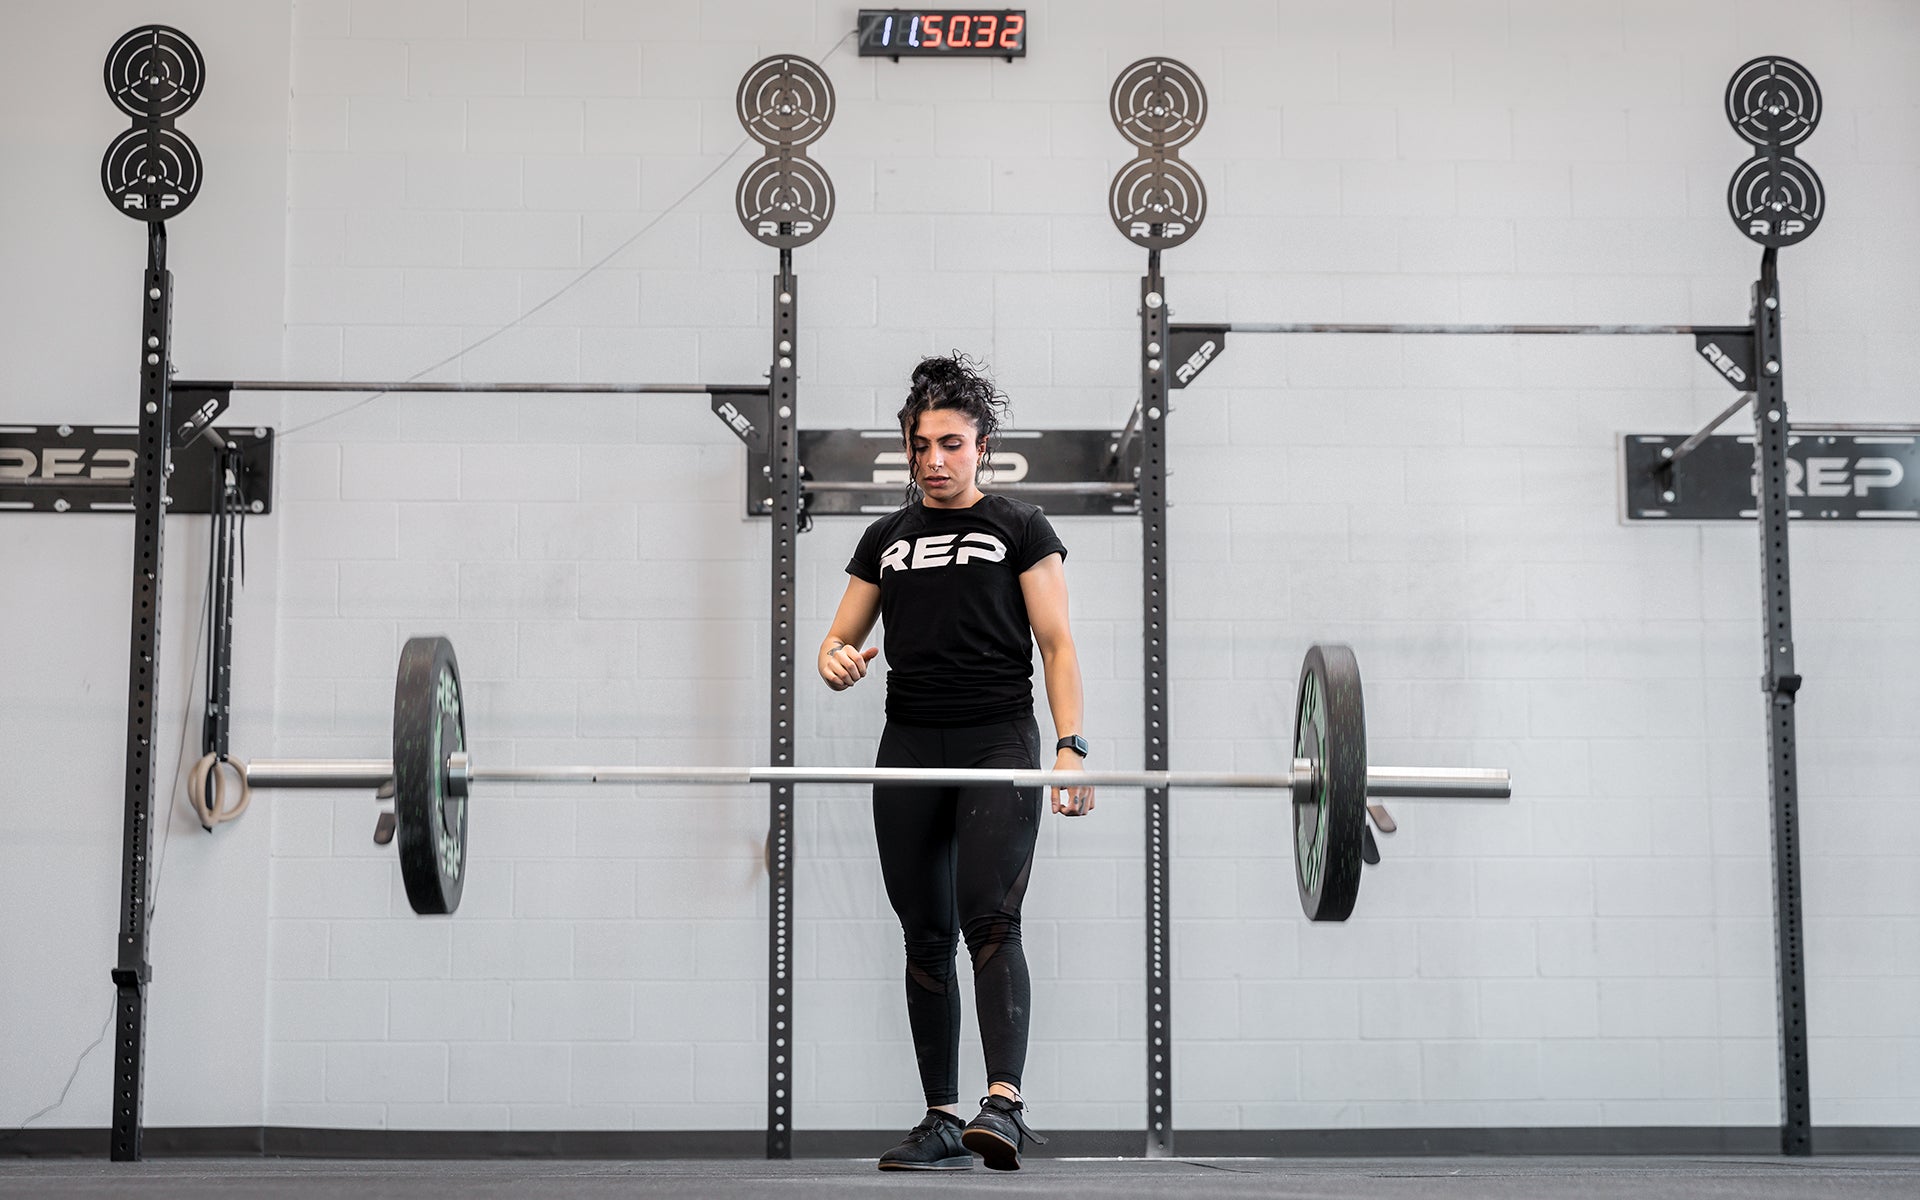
[{"x1": 0, "y1": 0, "x2": 292, "y2": 1127}]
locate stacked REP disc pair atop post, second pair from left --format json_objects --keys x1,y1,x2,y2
[{"x1": 733, "y1": 54, "x2": 833, "y2": 250}]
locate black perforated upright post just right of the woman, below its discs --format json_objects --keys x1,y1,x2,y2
[{"x1": 1139, "y1": 250, "x2": 1173, "y2": 1158}]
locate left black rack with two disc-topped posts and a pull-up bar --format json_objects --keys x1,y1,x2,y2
[{"x1": 102, "y1": 25, "x2": 833, "y2": 1162}]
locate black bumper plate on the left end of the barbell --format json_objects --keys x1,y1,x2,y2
[{"x1": 394, "y1": 637, "x2": 467, "y2": 916}]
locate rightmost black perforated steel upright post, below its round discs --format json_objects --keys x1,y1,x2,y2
[{"x1": 1753, "y1": 248, "x2": 1812, "y2": 1156}]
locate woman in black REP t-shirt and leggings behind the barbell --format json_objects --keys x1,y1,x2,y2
[{"x1": 818, "y1": 357, "x2": 1092, "y2": 1171}]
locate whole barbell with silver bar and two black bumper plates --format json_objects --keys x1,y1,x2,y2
[{"x1": 228, "y1": 637, "x2": 1513, "y2": 922}]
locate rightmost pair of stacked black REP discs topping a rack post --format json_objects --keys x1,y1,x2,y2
[{"x1": 1726, "y1": 54, "x2": 1826, "y2": 248}]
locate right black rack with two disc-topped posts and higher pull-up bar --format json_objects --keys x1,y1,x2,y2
[{"x1": 1108, "y1": 56, "x2": 1824, "y2": 1156}]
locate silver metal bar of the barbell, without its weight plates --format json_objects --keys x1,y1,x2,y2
[{"x1": 246, "y1": 755, "x2": 1513, "y2": 801}]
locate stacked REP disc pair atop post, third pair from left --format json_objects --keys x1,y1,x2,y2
[{"x1": 1106, "y1": 58, "x2": 1206, "y2": 250}]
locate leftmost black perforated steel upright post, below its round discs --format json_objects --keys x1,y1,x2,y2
[{"x1": 111, "y1": 221, "x2": 173, "y2": 1162}]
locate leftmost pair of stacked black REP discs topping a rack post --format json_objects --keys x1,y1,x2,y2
[{"x1": 100, "y1": 25, "x2": 205, "y2": 223}]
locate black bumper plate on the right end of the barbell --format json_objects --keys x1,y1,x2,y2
[{"x1": 1292, "y1": 645, "x2": 1367, "y2": 922}]
